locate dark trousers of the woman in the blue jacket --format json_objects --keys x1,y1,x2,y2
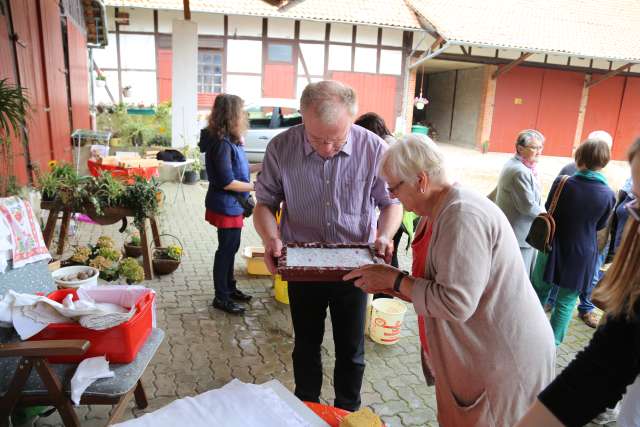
[{"x1": 213, "y1": 228, "x2": 242, "y2": 301}]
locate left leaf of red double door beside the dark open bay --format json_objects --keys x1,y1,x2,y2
[{"x1": 489, "y1": 67, "x2": 544, "y2": 153}]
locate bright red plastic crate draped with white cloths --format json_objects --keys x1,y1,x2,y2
[{"x1": 29, "y1": 289, "x2": 155, "y2": 363}]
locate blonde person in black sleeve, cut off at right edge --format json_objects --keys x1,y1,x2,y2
[{"x1": 516, "y1": 140, "x2": 640, "y2": 427}]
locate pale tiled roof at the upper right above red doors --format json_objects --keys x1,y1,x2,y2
[{"x1": 406, "y1": 0, "x2": 640, "y2": 62}]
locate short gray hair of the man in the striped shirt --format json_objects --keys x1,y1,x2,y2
[{"x1": 300, "y1": 80, "x2": 358, "y2": 124}]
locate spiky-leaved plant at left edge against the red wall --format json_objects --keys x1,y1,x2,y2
[{"x1": 0, "y1": 79, "x2": 31, "y2": 196}]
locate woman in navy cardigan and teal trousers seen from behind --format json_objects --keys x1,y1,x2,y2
[{"x1": 531, "y1": 140, "x2": 615, "y2": 345}]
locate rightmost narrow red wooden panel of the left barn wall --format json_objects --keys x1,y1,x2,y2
[{"x1": 67, "y1": 19, "x2": 91, "y2": 129}]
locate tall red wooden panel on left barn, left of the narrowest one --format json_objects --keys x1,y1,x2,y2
[{"x1": 39, "y1": 0, "x2": 71, "y2": 161}]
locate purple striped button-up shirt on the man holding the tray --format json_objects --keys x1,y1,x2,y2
[{"x1": 256, "y1": 125, "x2": 398, "y2": 243}]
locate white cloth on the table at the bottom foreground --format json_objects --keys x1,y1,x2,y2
[{"x1": 114, "y1": 379, "x2": 326, "y2": 427}]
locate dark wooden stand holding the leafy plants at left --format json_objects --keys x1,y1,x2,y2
[{"x1": 40, "y1": 201, "x2": 162, "y2": 280}]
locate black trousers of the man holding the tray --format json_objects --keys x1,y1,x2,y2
[{"x1": 289, "y1": 282, "x2": 367, "y2": 411}]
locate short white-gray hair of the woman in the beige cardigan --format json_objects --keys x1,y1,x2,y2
[{"x1": 379, "y1": 133, "x2": 446, "y2": 183}]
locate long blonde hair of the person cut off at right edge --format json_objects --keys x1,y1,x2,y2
[{"x1": 593, "y1": 139, "x2": 640, "y2": 319}]
